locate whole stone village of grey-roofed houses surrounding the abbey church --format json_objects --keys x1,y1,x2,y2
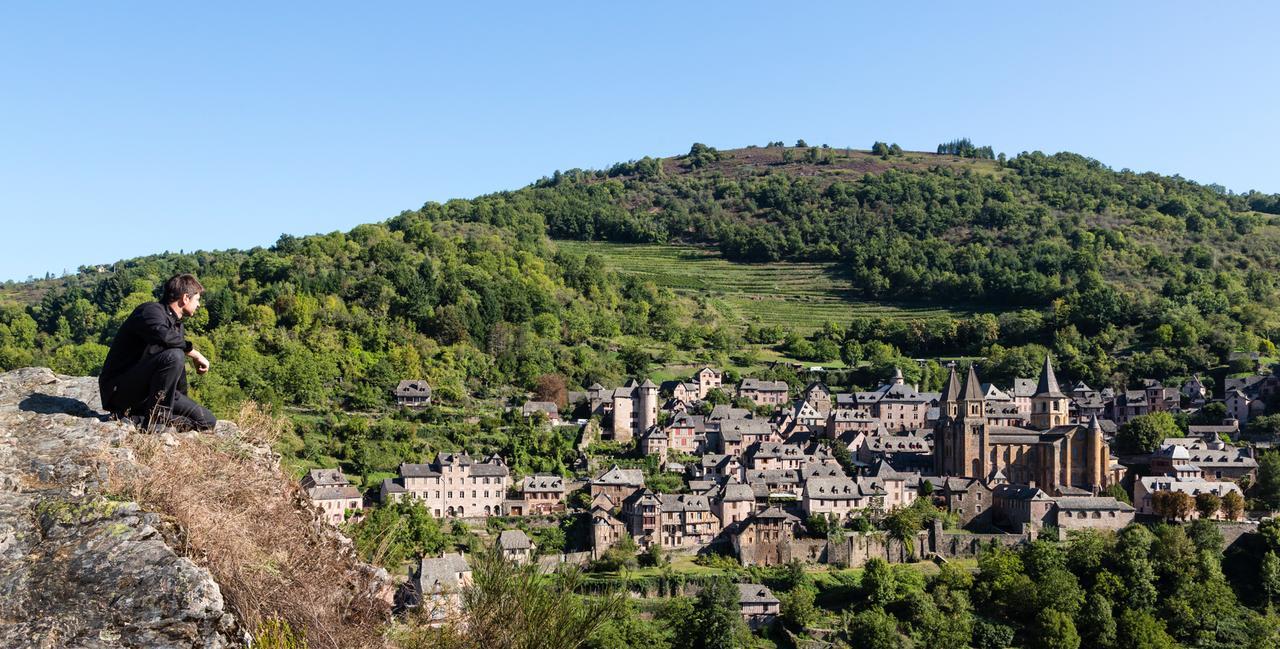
[{"x1": 302, "y1": 357, "x2": 1280, "y2": 623}]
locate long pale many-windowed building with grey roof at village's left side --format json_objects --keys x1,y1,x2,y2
[{"x1": 381, "y1": 453, "x2": 511, "y2": 518}]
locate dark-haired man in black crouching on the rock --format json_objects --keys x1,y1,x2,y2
[{"x1": 97, "y1": 274, "x2": 218, "y2": 430}]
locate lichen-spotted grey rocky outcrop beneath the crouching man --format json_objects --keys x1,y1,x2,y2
[{"x1": 0, "y1": 369, "x2": 239, "y2": 648}]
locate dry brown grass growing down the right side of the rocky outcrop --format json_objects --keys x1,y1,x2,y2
[{"x1": 113, "y1": 405, "x2": 390, "y2": 649}]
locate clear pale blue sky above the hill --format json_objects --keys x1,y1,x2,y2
[{"x1": 0, "y1": 3, "x2": 1280, "y2": 280}]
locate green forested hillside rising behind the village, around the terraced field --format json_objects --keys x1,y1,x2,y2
[{"x1": 0, "y1": 141, "x2": 1280, "y2": 422}]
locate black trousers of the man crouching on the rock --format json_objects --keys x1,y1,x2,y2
[{"x1": 102, "y1": 348, "x2": 218, "y2": 429}]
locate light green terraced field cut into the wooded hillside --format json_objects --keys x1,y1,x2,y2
[{"x1": 556, "y1": 241, "x2": 972, "y2": 332}]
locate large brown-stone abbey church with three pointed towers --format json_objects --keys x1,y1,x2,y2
[{"x1": 933, "y1": 357, "x2": 1114, "y2": 495}]
